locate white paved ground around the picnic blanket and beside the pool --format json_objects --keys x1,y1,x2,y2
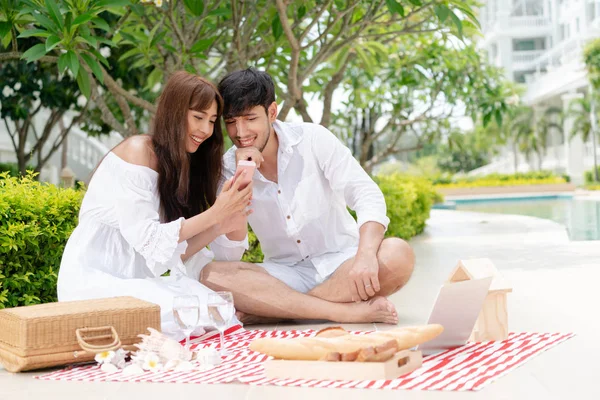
[{"x1": 0, "y1": 210, "x2": 600, "y2": 400}]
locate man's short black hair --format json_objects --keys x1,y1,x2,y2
[{"x1": 219, "y1": 68, "x2": 275, "y2": 119}]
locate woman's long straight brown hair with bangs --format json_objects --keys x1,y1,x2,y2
[{"x1": 152, "y1": 71, "x2": 223, "y2": 222}]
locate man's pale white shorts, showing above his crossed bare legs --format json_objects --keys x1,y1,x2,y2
[{"x1": 256, "y1": 248, "x2": 357, "y2": 293}]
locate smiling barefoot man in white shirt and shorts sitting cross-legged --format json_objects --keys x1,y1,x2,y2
[{"x1": 201, "y1": 69, "x2": 414, "y2": 324}]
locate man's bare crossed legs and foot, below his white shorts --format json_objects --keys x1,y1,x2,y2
[{"x1": 200, "y1": 238, "x2": 415, "y2": 324}]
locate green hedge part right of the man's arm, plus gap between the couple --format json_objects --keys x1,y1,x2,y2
[{"x1": 242, "y1": 174, "x2": 444, "y2": 262}]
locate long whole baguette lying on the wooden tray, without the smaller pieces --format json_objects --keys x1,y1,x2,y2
[{"x1": 250, "y1": 324, "x2": 443, "y2": 361}]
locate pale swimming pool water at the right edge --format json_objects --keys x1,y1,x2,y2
[{"x1": 455, "y1": 197, "x2": 600, "y2": 240}]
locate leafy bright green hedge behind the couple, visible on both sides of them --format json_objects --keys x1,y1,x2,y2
[{"x1": 0, "y1": 172, "x2": 442, "y2": 309}]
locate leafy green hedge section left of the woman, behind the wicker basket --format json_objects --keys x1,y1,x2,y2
[{"x1": 0, "y1": 172, "x2": 83, "y2": 308}]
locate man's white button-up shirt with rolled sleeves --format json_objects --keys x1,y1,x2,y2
[{"x1": 211, "y1": 121, "x2": 389, "y2": 277}]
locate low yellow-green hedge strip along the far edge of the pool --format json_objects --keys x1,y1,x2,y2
[{"x1": 433, "y1": 171, "x2": 569, "y2": 189}]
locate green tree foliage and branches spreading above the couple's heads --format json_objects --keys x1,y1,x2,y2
[{"x1": 0, "y1": 0, "x2": 505, "y2": 168}]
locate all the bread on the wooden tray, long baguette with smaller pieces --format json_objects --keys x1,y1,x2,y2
[{"x1": 250, "y1": 324, "x2": 444, "y2": 361}]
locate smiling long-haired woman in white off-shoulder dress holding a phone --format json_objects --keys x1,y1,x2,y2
[{"x1": 58, "y1": 72, "x2": 252, "y2": 332}]
